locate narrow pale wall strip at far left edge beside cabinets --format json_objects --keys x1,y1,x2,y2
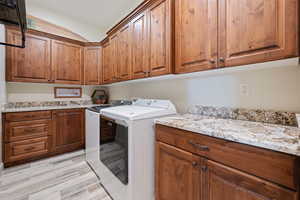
[{"x1": 0, "y1": 25, "x2": 6, "y2": 171}]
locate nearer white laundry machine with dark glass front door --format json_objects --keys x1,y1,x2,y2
[{"x1": 87, "y1": 99, "x2": 176, "y2": 200}]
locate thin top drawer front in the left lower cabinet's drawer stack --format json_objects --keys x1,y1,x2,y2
[{"x1": 5, "y1": 111, "x2": 51, "y2": 122}]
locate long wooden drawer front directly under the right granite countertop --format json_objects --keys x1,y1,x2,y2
[{"x1": 156, "y1": 125, "x2": 300, "y2": 189}]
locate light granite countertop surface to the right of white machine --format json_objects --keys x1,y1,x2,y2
[{"x1": 155, "y1": 114, "x2": 300, "y2": 156}]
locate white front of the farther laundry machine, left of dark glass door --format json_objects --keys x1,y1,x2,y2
[{"x1": 85, "y1": 109, "x2": 100, "y2": 170}]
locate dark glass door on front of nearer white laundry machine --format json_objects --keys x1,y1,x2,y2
[{"x1": 100, "y1": 116, "x2": 128, "y2": 185}]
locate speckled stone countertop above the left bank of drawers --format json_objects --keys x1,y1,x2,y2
[{"x1": 0, "y1": 101, "x2": 99, "y2": 113}]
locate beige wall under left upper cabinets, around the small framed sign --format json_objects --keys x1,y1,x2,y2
[{"x1": 6, "y1": 83, "x2": 104, "y2": 102}]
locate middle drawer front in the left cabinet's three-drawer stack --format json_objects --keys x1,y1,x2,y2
[{"x1": 4, "y1": 120, "x2": 51, "y2": 142}]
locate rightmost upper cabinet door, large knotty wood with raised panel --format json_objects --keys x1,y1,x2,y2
[{"x1": 219, "y1": 0, "x2": 298, "y2": 66}]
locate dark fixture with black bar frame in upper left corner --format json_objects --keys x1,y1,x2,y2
[{"x1": 0, "y1": 0, "x2": 27, "y2": 48}]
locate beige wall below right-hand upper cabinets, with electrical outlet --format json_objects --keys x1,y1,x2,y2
[{"x1": 110, "y1": 59, "x2": 300, "y2": 112}]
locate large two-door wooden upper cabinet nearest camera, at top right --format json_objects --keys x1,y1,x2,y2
[{"x1": 175, "y1": 0, "x2": 299, "y2": 73}]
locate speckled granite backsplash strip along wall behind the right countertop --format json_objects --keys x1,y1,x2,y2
[{"x1": 188, "y1": 105, "x2": 300, "y2": 127}]
